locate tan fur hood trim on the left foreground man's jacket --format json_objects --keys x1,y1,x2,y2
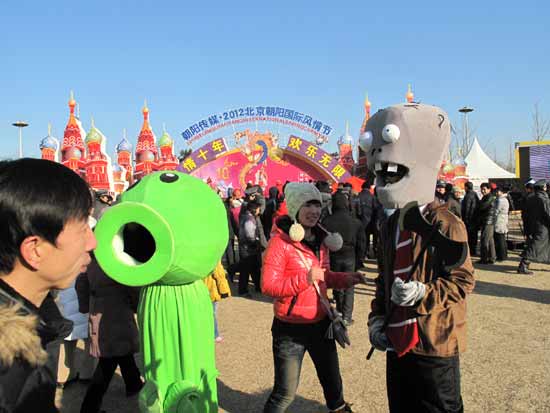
[{"x1": 0, "y1": 305, "x2": 48, "y2": 366}]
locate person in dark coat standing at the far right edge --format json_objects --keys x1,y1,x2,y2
[{"x1": 518, "y1": 180, "x2": 550, "y2": 275}]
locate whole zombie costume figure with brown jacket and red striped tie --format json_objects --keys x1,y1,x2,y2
[{"x1": 360, "y1": 103, "x2": 474, "y2": 412}]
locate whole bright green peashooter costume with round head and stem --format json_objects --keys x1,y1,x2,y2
[{"x1": 95, "y1": 172, "x2": 228, "y2": 413}]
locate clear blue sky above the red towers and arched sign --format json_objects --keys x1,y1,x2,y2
[{"x1": 0, "y1": 0, "x2": 550, "y2": 164}]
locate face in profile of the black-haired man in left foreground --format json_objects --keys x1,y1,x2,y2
[{"x1": 38, "y1": 219, "x2": 96, "y2": 289}]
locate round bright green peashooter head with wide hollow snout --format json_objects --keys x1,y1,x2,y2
[{"x1": 95, "y1": 171, "x2": 228, "y2": 286}]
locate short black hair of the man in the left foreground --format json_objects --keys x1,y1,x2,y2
[{"x1": 0, "y1": 158, "x2": 92, "y2": 274}]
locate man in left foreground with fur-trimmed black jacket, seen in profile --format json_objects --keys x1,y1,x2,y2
[{"x1": 0, "y1": 158, "x2": 96, "y2": 413}]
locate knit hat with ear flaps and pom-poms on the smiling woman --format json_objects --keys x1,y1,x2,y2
[{"x1": 285, "y1": 182, "x2": 344, "y2": 251}]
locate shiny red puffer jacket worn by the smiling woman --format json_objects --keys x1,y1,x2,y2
[{"x1": 262, "y1": 228, "x2": 348, "y2": 324}]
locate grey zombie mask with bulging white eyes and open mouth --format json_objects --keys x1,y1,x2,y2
[{"x1": 359, "y1": 103, "x2": 451, "y2": 209}]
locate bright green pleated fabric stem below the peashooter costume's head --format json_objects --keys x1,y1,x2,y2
[{"x1": 138, "y1": 280, "x2": 218, "y2": 413}]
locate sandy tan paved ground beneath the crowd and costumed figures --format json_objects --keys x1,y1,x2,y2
[{"x1": 57, "y1": 249, "x2": 550, "y2": 413}]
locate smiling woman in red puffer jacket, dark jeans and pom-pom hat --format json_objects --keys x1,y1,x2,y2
[{"x1": 262, "y1": 183, "x2": 363, "y2": 413}]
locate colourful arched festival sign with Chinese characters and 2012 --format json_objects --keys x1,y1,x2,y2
[{"x1": 178, "y1": 106, "x2": 351, "y2": 189}]
